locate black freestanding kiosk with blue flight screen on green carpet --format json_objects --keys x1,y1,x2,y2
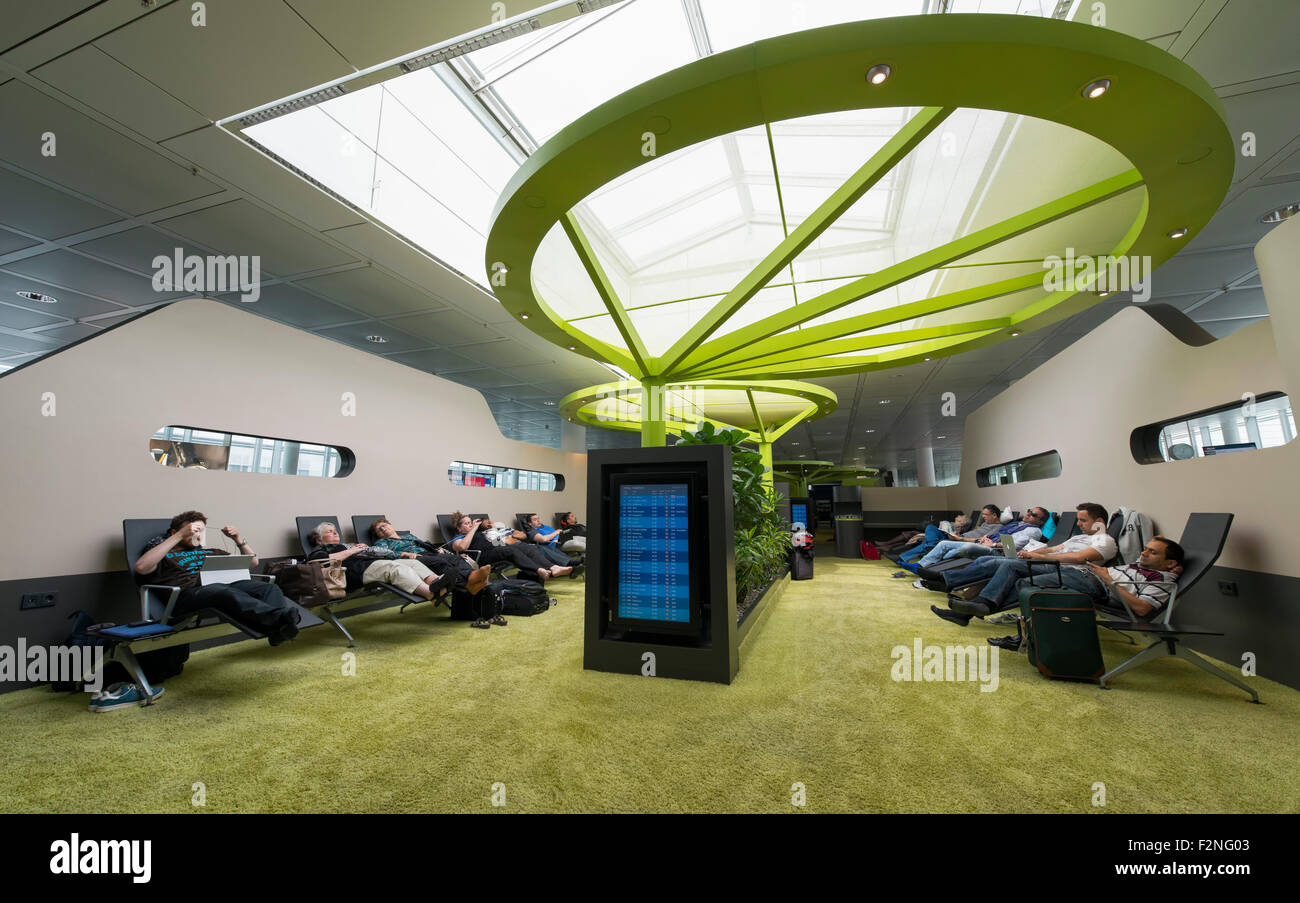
[{"x1": 582, "y1": 446, "x2": 740, "y2": 683}]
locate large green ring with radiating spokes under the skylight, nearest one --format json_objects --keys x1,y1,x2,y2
[{"x1": 485, "y1": 14, "x2": 1234, "y2": 382}]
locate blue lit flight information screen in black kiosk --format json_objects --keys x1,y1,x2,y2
[{"x1": 618, "y1": 483, "x2": 692, "y2": 625}]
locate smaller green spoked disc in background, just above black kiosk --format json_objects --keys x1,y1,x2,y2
[{"x1": 560, "y1": 379, "x2": 839, "y2": 444}]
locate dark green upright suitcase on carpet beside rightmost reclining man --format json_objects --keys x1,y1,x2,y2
[{"x1": 1019, "y1": 566, "x2": 1106, "y2": 682}]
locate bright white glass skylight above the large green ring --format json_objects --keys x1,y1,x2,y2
[{"x1": 246, "y1": 0, "x2": 1097, "y2": 353}]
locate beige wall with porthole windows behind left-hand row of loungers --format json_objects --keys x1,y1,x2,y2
[{"x1": 0, "y1": 299, "x2": 586, "y2": 579}]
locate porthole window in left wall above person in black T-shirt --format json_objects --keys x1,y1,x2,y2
[{"x1": 150, "y1": 426, "x2": 356, "y2": 477}]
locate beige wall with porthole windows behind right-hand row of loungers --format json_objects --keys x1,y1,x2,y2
[{"x1": 948, "y1": 310, "x2": 1300, "y2": 577}]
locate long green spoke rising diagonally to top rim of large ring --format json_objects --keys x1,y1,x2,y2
[{"x1": 659, "y1": 107, "x2": 953, "y2": 374}]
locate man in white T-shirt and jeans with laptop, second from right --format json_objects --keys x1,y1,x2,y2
[{"x1": 919, "y1": 502, "x2": 1119, "y2": 626}]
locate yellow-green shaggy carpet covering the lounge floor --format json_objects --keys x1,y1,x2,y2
[{"x1": 0, "y1": 556, "x2": 1300, "y2": 812}]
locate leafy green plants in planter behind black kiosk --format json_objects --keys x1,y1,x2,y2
[{"x1": 677, "y1": 421, "x2": 789, "y2": 605}]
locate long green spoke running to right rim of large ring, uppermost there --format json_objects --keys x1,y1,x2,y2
[{"x1": 664, "y1": 169, "x2": 1143, "y2": 377}]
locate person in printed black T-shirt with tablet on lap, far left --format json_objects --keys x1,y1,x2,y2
[{"x1": 135, "y1": 511, "x2": 300, "y2": 646}]
